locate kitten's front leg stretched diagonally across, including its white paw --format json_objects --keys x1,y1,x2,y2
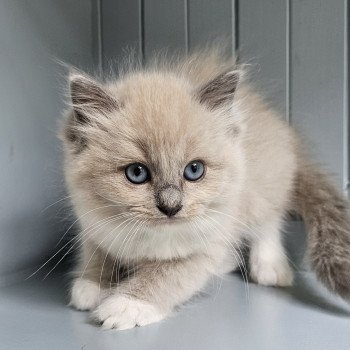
[{"x1": 93, "y1": 255, "x2": 216, "y2": 330}]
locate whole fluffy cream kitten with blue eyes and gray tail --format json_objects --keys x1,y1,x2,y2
[{"x1": 62, "y1": 50, "x2": 350, "y2": 329}]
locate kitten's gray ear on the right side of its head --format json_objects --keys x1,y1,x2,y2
[{"x1": 198, "y1": 70, "x2": 240, "y2": 109}]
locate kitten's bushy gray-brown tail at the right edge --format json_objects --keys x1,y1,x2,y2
[{"x1": 295, "y1": 165, "x2": 350, "y2": 300}]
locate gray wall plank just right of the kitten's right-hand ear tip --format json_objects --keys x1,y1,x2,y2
[{"x1": 238, "y1": 0, "x2": 288, "y2": 118}]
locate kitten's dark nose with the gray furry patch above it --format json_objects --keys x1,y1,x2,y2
[{"x1": 156, "y1": 185, "x2": 182, "y2": 217}]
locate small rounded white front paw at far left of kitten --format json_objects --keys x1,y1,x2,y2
[{"x1": 69, "y1": 278, "x2": 102, "y2": 311}]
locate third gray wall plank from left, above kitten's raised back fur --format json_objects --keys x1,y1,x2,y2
[{"x1": 188, "y1": 0, "x2": 235, "y2": 52}]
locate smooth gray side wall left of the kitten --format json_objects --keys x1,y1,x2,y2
[{"x1": 0, "y1": 0, "x2": 95, "y2": 280}]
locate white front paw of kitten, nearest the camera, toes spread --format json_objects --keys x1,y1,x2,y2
[{"x1": 92, "y1": 294, "x2": 165, "y2": 330}]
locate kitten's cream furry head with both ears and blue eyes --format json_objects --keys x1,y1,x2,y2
[{"x1": 63, "y1": 58, "x2": 243, "y2": 258}]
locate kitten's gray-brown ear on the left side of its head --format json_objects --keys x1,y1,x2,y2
[{"x1": 69, "y1": 73, "x2": 118, "y2": 123}]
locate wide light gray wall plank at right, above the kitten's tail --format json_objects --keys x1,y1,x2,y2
[{"x1": 290, "y1": 0, "x2": 348, "y2": 188}]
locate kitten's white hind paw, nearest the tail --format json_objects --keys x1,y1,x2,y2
[{"x1": 250, "y1": 260, "x2": 294, "y2": 287}]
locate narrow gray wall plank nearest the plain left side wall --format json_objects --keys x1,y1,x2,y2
[{"x1": 101, "y1": 0, "x2": 142, "y2": 70}]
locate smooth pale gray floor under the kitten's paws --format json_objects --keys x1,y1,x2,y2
[{"x1": 0, "y1": 273, "x2": 350, "y2": 350}]
